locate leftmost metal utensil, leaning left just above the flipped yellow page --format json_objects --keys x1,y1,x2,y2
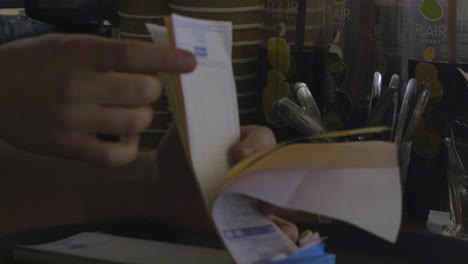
[{"x1": 272, "y1": 97, "x2": 325, "y2": 136}]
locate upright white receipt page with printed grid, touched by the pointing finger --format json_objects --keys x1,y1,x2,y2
[{"x1": 173, "y1": 16, "x2": 240, "y2": 209}]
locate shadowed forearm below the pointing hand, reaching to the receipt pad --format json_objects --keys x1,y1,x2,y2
[{"x1": 0, "y1": 128, "x2": 213, "y2": 231}]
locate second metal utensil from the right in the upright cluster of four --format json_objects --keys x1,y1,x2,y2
[{"x1": 394, "y1": 79, "x2": 418, "y2": 144}]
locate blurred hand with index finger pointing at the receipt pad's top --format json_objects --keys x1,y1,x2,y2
[{"x1": 0, "y1": 32, "x2": 196, "y2": 166}]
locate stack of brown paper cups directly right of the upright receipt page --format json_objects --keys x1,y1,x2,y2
[{"x1": 169, "y1": 0, "x2": 263, "y2": 124}]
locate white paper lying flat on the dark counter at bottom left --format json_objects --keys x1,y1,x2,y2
[{"x1": 14, "y1": 232, "x2": 234, "y2": 264}]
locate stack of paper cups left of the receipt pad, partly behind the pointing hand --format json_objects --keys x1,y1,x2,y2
[{"x1": 119, "y1": 0, "x2": 173, "y2": 151}]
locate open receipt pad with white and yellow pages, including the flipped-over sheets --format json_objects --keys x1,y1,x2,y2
[{"x1": 147, "y1": 15, "x2": 401, "y2": 263}]
